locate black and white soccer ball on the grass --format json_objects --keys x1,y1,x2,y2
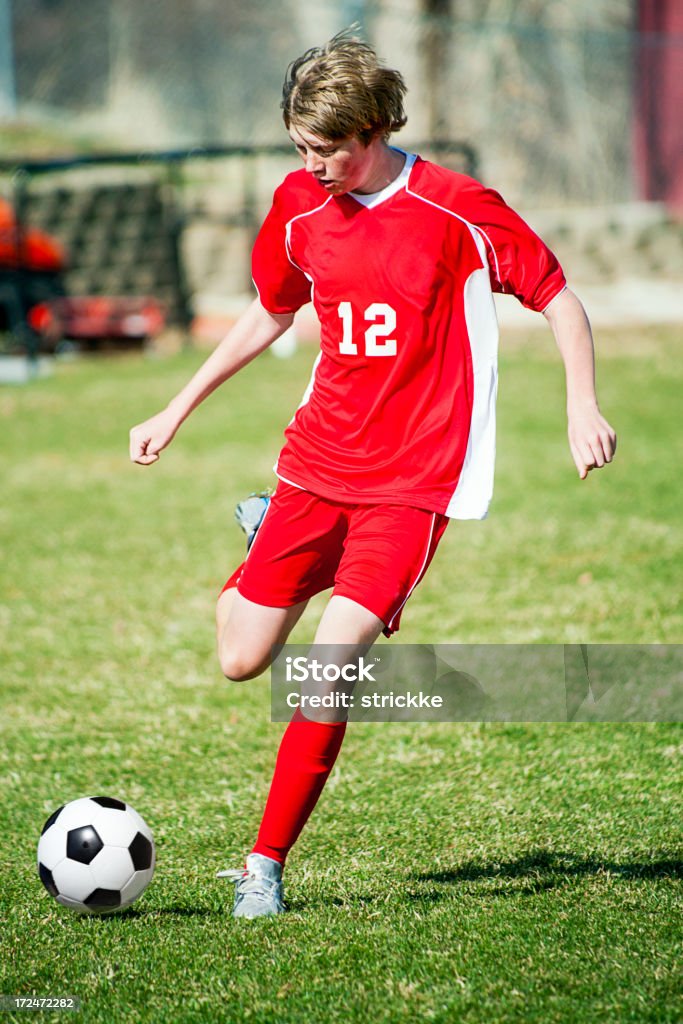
[{"x1": 38, "y1": 797, "x2": 155, "y2": 913}]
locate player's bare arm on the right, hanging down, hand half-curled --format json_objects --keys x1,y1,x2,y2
[{"x1": 544, "y1": 288, "x2": 616, "y2": 480}]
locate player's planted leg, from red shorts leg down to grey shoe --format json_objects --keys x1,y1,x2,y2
[{"x1": 223, "y1": 507, "x2": 447, "y2": 918}]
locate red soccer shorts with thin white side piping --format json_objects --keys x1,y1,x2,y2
[{"x1": 223, "y1": 480, "x2": 449, "y2": 636}]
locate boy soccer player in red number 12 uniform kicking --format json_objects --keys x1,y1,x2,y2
[{"x1": 130, "y1": 34, "x2": 616, "y2": 918}]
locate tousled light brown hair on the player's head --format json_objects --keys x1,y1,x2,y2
[{"x1": 281, "y1": 31, "x2": 407, "y2": 145}]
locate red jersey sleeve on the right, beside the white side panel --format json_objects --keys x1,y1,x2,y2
[{"x1": 467, "y1": 180, "x2": 566, "y2": 312}]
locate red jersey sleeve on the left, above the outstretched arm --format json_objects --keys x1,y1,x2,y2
[{"x1": 252, "y1": 184, "x2": 310, "y2": 314}]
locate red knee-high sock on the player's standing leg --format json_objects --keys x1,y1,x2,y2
[{"x1": 252, "y1": 710, "x2": 346, "y2": 864}]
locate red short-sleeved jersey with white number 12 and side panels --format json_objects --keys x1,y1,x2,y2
[{"x1": 252, "y1": 155, "x2": 565, "y2": 519}]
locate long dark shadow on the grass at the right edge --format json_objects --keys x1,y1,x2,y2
[{"x1": 410, "y1": 850, "x2": 683, "y2": 891}]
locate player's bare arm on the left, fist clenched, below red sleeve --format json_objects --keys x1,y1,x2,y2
[{"x1": 130, "y1": 299, "x2": 294, "y2": 466}]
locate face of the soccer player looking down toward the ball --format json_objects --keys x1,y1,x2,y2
[{"x1": 290, "y1": 125, "x2": 377, "y2": 196}]
